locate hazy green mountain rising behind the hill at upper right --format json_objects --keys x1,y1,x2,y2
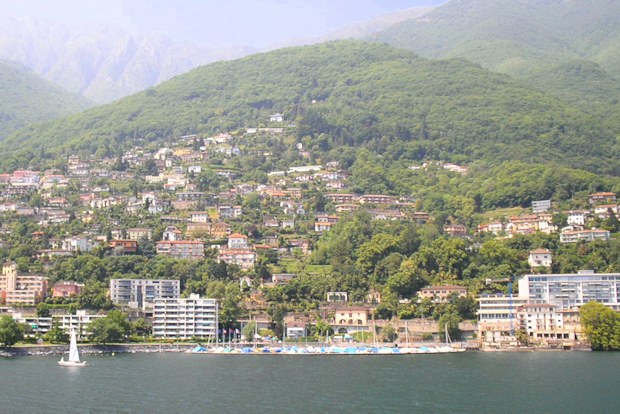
[{"x1": 370, "y1": 0, "x2": 620, "y2": 121}]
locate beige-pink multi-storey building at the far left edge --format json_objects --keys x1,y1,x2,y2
[{"x1": 0, "y1": 262, "x2": 48, "y2": 305}]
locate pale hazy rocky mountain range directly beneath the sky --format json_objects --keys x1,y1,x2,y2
[{"x1": 0, "y1": 17, "x2": 253, "y2": 103}]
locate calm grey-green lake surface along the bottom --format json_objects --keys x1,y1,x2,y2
[{"x1": 0, "y1": 352, "x2": 620, "y2": 414}]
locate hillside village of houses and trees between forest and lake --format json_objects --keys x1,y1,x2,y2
[{"x1": 0, "y1": 113, "x2": 620, "y2": 347}]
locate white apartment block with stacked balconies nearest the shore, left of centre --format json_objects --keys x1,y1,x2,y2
[{"x1": 153, "y1": 294, "x2": 219, "y2": 339}]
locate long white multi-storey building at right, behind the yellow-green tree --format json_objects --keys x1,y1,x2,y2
[{"x1": 518, "y1": 270, "x2": 620, "y2": 311}]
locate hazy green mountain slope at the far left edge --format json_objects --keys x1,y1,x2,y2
[{"x1": 0, "y1": 61, "x2": 92, "y2": 140}]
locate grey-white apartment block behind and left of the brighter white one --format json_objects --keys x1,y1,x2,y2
[{"x1": 110, "y1": 279, "x2": 181, "y2": 309}]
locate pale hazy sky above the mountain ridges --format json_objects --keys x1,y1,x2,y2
[{"x1": 0, "y1": 0, "x2": 446, "y2": 47}]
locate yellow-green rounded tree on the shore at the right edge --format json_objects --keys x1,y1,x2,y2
[{"x1": 579, "y1": 302, "x2": 620, "y2": 351}]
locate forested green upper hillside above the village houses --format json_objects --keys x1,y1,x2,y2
[{"x1": 0, "y1": 41, "x2": 620, "y2": 174}]
